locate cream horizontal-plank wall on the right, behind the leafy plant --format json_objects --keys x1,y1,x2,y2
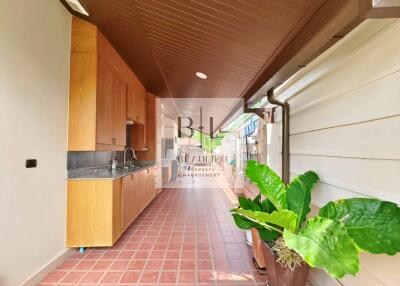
[{"x1": 268, "y1": 20, "x2": 400, "y2": 286}]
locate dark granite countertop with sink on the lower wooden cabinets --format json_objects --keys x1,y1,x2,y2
[{"x1": 67, "y1": 163, "x2": 155, "y2": 181}]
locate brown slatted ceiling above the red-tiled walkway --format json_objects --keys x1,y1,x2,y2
[{"x1": 68, "y1": 0, "x2": 324, "y2": 98}]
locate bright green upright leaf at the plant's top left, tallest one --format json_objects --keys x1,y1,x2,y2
[{"x1": 246, "y1": 160, "x2": 287, "y2": 210}]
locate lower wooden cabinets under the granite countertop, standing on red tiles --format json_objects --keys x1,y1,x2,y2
[{"x1": 67, "y1": 167, "x2": 156, "y2": 247}]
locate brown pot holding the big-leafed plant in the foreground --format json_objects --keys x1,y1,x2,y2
[{"x1": 262, "y1": 241, "x2": 310, "y2": 286}]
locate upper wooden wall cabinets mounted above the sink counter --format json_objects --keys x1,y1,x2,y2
[{"x1": 68, "y1": 17, "x2": 146, "y2": 151}]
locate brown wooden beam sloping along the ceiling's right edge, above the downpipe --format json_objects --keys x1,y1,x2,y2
[{"x1": 242, "y1": 0, "x2": 362, "y2": 105}]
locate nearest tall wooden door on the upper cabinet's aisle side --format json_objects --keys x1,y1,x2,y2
[{"x1": 96, "y1": 57, "x2": 115, "y2": 144}]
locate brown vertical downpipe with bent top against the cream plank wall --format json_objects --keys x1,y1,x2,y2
[{"x1": 267, "y1": 88, "x2": 290, "y2": 184}]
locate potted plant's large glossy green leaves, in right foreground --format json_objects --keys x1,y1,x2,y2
[{"x1": 231, "y1": 161, "x2": 400, "y2": 278}]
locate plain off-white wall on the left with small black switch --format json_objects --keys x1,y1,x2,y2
[{"x1": 0, "y1": 0, "x2": 71, "y2": 286}]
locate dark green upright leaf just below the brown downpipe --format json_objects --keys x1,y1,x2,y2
[{"x1": 286, "y1": 171, "x2": 319, "y2": 228}]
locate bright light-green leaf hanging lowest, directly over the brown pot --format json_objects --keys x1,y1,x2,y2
[{"x1": 283, "y1": 217, "x2": 360, "y2": 278}]
